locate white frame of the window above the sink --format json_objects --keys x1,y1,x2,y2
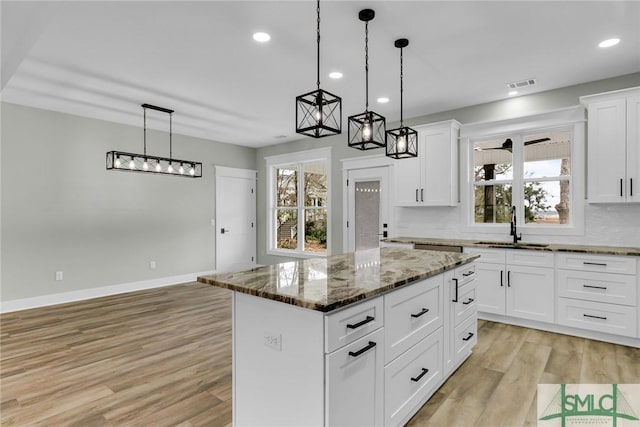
[{"x1": 460, "y1": 106, "x2": 586, "y2": 238}]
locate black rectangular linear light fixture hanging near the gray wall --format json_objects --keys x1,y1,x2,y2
[{"x1": 107, "y1": 104, "x2": 202, "y2": 178}]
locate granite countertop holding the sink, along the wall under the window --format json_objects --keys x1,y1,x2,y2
[{"x1": 383, "y1": 237, "x2": 640, "y2": 256}]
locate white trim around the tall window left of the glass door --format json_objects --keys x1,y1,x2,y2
[{"x1": 264, "y1": 147, "x2": 331, "y2": 258}]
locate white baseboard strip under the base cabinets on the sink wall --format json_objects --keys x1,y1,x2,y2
[{"x1": 478, "y1": 312, "x2": 640, "y2": 348}]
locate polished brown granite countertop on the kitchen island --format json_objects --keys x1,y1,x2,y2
[{"x1": 198, "y1": 247, "x2": 479, "y2": 312}]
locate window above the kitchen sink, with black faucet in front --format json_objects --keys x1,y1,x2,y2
[{"x1": 471, "y1": 128, "x2": 573, "y2": 226}]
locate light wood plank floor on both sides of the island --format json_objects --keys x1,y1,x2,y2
[{"x1": 0, "y1": 284, "x2": 640, "y2": 427}]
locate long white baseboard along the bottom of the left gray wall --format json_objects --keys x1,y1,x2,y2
[{"x1": 0, "y1": 270, "x2": 215, "y2": 313}]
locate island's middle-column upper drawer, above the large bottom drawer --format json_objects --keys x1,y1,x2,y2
[{"x1": 384, "y1": 275, "x2": 443, "y2": 363}]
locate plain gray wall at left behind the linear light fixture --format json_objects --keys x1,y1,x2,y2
[{"x1": 0, "y1": 103, "x2": 256, "y2": 301}]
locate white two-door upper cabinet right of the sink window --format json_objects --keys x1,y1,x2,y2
[{"x1": 580, "y1": 88, "x2": 640, "y2": 203}]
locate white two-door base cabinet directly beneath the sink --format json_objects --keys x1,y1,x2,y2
[{"x1": 465, "y1": 248, "x2": 555, "y2": 323}]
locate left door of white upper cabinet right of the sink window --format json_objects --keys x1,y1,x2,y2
[{"x1": 587, "y1": 98, "x2": 626, "y2": 203}]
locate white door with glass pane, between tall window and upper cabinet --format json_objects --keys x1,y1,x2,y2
[{"x1": 347, "y1": 166, "x2": 390, "y2": 252}]
